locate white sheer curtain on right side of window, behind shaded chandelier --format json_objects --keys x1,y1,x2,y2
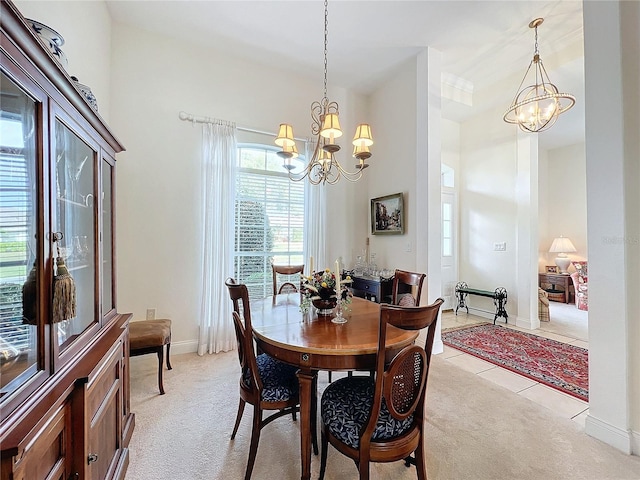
[{"x1": 304, "y1": 141, "x2": 329, "y2": 272}]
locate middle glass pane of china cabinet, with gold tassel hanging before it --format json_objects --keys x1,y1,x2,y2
[{"x1": 52, "y1": 119, "x2": 97, "y2": 348}]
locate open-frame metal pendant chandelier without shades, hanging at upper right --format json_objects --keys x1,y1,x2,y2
[{"x1": 503, "y1": 18, "x2": 576, "y2": 133}]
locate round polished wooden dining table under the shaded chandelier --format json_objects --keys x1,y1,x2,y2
[{"x1": 251, "y1": 293, "x2": 418, "y2": 480}]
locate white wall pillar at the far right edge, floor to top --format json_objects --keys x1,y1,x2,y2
[{"x1": 583, "y1": 2, "x2": 640, "y2": 455}]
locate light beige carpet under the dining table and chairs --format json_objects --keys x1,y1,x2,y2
[{"x1": 126, "y1": 352, "x2": 640, "y2": 480}]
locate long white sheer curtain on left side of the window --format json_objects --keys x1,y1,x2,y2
[{"x1": 198, "y1": 121, "x2": 238, "y2": 355}]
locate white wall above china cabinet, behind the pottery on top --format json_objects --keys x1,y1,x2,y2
[{"x1": 14, "y1": 0, "x2": 111, "y2": 121}]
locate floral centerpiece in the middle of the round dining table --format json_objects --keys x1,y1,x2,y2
[{"x1": 300, "y1": 268, "x2": 351, "y2": 315}]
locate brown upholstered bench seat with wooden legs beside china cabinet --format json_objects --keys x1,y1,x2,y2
[{"x1": 129, "y1": 319, "x2": 171, "y2": 395}]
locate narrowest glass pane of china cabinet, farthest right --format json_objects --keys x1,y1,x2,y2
[{"x1": 102, "y1": 160, "x2": 115, "y2": 315}]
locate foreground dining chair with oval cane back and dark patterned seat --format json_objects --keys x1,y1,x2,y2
[{"x1": 320, "y1": 298, "x2": 444, "y2": 480}]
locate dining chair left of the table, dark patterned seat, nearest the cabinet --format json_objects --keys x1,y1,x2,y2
[{"x1": 225, "y1": 278, "x2": 308, "y2": 480}]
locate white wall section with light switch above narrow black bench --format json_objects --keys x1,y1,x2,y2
[{"x1": 458, "y1": 104, "x2": 518, "y2": 318}]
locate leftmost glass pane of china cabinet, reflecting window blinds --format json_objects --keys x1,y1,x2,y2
[{"x1": 0, "y1": 72, "x2": 42, "y2": 398}]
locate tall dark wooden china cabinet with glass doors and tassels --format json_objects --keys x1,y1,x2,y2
[{"x1": 0, "y1": 0, "x2": 134, "y2": 480}]
